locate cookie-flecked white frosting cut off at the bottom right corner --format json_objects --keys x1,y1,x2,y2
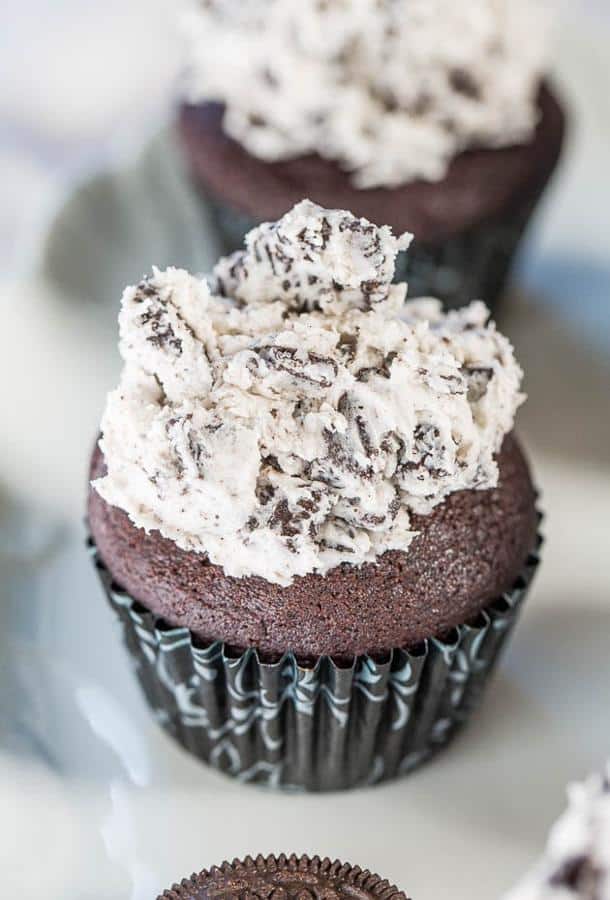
[{"x1": 505, "y1": 764, "x2": 610, "y2": 900}]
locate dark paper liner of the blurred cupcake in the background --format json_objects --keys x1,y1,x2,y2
[{"x1": 206, "y1": 197, "x2": 536, "y2": 311}]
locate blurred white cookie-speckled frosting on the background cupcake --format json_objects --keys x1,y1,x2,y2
[{"x1": 184, "y1": 0, "x2": 546, "y2": 188}]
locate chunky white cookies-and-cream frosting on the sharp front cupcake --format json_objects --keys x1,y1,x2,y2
[{"x1": 94, "y1": 201, "x2": 523, "y2": 585}]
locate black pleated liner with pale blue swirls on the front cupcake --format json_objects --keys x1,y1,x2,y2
[{"x1": 89, "y1": 537, "x2": 541, "y2": 791}]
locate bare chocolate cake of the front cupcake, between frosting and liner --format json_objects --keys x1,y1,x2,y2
[{"x1": 88, "y1": 436, "x2": 537, "y2": 659}]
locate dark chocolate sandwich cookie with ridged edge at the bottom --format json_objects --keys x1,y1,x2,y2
[{"x1": 158, "y1": 853, "x2": 407, "y2": 900}]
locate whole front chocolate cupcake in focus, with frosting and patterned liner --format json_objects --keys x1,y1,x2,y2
[{"x1": 88, "y1": 201, "x2": 539, "y2": 790}]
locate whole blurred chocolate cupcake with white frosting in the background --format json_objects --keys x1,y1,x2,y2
[{"x1": 179, "y1": 0, "x2": 564, "y2": 308}]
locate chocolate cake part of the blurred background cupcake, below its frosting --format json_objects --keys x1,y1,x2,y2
[{"x1": 179, "y1": 85, "x2": 565, "y2": 246}]
